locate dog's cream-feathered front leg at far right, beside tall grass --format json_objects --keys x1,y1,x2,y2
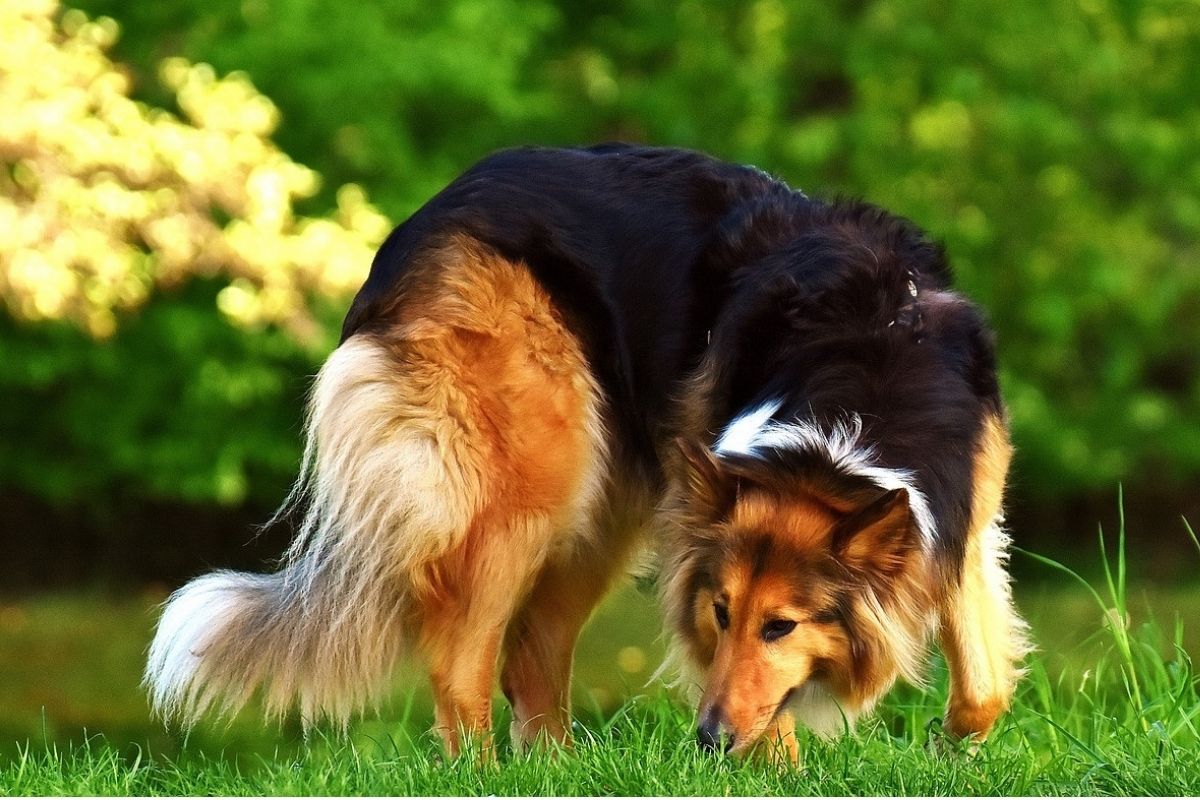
[{"x1": 941, "y1": 417, "x2": 1030, "y2": 741}]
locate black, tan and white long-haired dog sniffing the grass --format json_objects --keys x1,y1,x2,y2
[{"x1": 145, "y1": 144, "x2": 1028, "y2": 760}]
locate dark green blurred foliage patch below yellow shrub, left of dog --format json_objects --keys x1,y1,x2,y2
[{"x1": 0, "y1": 282, "x2": 331, "y2": 509}]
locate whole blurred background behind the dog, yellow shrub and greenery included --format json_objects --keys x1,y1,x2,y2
[{"x1": 0, "y1": 0, "x2": 1200, "y2": 753}]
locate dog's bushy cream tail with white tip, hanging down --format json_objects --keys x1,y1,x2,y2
[{"x1": 144, "y1": 336, "x2": 473, "y2": 724}]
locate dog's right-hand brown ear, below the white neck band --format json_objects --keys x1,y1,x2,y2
[{"x1": 832, "y1": 489, "x2": 919, "y2": 581}]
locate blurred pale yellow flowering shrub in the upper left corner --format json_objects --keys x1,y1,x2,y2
[{"x1": 0, "y1": 0, "x2": 389, "y2": 337}]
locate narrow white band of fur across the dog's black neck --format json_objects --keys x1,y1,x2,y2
[{"x1": 714, "y1": 399, "x2": 937, "y2": 545}]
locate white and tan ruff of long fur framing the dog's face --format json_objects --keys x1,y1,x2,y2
[{"x1": 655, "y1": 424, "x2": 940, "y2": 714}]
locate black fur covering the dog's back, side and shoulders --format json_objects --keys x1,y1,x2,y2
[{"x1": 342, "y1": 144, "x2": 1002, "y2": 563}]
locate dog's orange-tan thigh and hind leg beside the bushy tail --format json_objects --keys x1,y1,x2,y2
[{"x1": 398, "y1": 237, "x2": 605, "y2": 752}]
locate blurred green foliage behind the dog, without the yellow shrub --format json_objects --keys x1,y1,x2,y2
[{"x1": 7, "y1": 0, "x2": 1200, "y2": 513}]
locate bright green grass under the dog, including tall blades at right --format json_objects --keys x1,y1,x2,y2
[{"x1": 0, "y1": 513, "x2": 1200, "y2": 795}]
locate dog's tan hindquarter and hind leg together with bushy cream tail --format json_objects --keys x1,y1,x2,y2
[{"x1": 145, "y1": 236, "x2": 606, "y2": 752}]
